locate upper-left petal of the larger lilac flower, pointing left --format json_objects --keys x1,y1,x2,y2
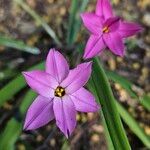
[{"x1": 23, "y1": 71, "x2": 58, "y2": 98}]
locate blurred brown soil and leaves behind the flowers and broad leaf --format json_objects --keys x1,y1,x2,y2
[{"x1": 0, "y1": 0, "x2": 150, "y2": 150}]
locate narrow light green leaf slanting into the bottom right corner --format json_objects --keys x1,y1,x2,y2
[{"x1": 116, "y1": 101, "x2": 150, "y2": 148}]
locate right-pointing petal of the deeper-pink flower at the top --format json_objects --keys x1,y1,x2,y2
[{"x1": 119, "y1": 21, "x2": 142, "y2": 38}]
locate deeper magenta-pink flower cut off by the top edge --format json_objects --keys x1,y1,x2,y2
[{"x1": 81, "y1": 0, "x2": 142, "y2": 59}]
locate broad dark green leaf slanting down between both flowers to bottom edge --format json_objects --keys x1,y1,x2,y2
[{"x1": 90, "y1": 56, "x2": 131, "y2": 150}]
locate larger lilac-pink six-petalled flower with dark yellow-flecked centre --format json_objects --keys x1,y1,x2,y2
[{"x1": 23, "y1": 49, "x2": 99, "y2": 137}]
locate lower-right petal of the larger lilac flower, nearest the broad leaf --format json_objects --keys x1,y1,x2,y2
[{"x1": 70, "y1": 88, "x2": 100, "y2": 112}]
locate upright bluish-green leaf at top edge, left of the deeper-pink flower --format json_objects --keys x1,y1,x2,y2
[{"x1": 67, "y1": 0, "x2": 89, "y2": 45}]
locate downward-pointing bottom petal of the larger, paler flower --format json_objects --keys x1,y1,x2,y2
[{"x1": 53, "y1": 96, "x2": 76, "y2": 138}]
